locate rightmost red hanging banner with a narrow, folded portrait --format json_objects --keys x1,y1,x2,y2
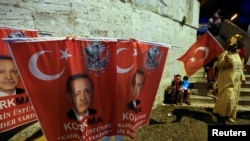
[{"x1": 115, "y1": 40, "x2": 168, "y2": 139}]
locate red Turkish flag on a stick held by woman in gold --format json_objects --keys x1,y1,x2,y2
[{"x1": 177, "y1": 32, "x2": 223, "y2": 76}]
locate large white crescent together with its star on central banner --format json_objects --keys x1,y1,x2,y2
[{"x1": 28, "y1": 49, "x2": 72, "y2": 81}]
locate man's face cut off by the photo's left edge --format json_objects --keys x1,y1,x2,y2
[{"x1": 0, "y1": 59, "x2": 19, "y2": 94}]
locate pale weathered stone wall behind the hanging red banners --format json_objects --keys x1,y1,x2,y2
[{"x1": 0, "y1": 0, "x2": 200, "y2": 106}]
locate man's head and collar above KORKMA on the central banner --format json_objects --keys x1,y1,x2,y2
[{"x1": 66, "y1": 74, "x2": 97, "y2": 121}]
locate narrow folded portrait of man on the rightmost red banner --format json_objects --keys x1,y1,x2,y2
[{"x1": 128, "y1": 69, "x2": 145, "y2": 111}]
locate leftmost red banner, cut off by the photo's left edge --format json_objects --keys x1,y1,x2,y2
[{"x1": 0, "y1": 27, "x2": 38, "y2": 140}]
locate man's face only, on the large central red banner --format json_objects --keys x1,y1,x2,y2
[{"x1": 70, "y1": 78, "x2": 93, "y2": 116}]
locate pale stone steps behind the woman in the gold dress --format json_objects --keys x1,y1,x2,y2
[{"x1": 189, "y1": 68, "x2": 250, "y2": 111}]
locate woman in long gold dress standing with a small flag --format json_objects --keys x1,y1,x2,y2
[{"x1": 213, "y1": 34, "x2": 246, "y2": 124}]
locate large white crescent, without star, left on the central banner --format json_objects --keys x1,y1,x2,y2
[{"x1": 29, "y1": 51, "x2": 65, "y2": 81}]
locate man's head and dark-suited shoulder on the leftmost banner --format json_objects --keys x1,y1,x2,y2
[{"x1": 0, "y1": 55, "x2": 25, "y2": 97}]
